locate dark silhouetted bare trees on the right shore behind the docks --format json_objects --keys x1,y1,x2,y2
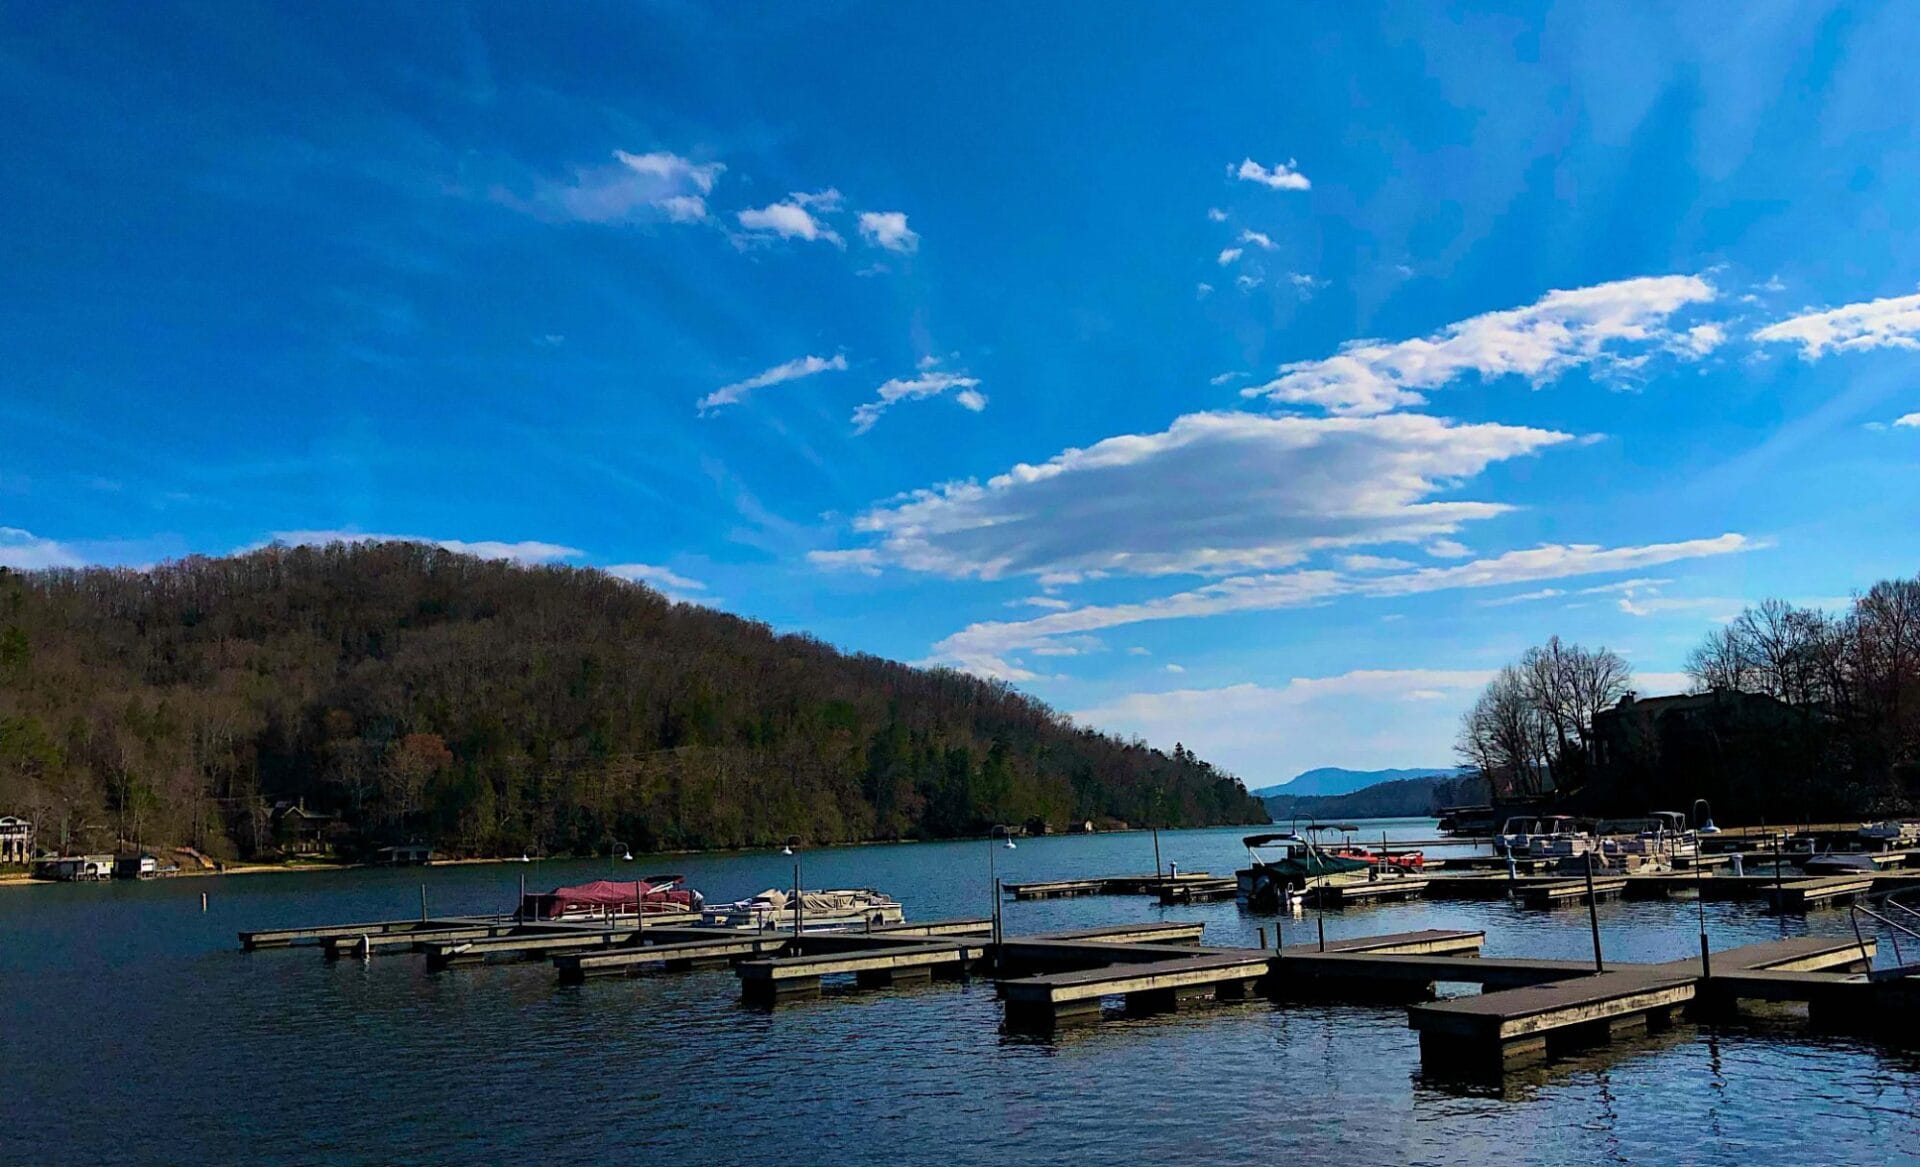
[{"x1": 1457, "y1": 578, "x2": 1920, "y2": 822}]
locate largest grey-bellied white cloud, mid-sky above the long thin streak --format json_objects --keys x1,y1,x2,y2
[{"x1": 829, "y1": 413, "x2": 1572, "y2": 580}]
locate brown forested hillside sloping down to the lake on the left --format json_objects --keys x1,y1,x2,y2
[{"x1": 0, "y1": 543, "x2": 1265, "y2": 854}]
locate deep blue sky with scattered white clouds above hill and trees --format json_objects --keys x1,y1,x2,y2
[{"x1": 0, "y1": 4, "x2": 1920, "y2": 785}]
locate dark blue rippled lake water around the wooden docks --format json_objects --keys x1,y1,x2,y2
[{"x1": 0, "y1": 820, "x2": 1920, "y2": 1167}]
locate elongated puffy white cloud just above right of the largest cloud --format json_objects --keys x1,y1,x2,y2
[{"x1": 1242, "y1": 276, "x2": 1715, "y2": 415}]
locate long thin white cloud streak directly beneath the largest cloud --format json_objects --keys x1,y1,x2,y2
[{"x1": 933, "y1": 534, "x2": 1764, "y2": 679}]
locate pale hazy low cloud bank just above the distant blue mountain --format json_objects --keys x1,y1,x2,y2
[{"x1": 1073, "y1": 668, "x2": 1494, "y2": 787}]
